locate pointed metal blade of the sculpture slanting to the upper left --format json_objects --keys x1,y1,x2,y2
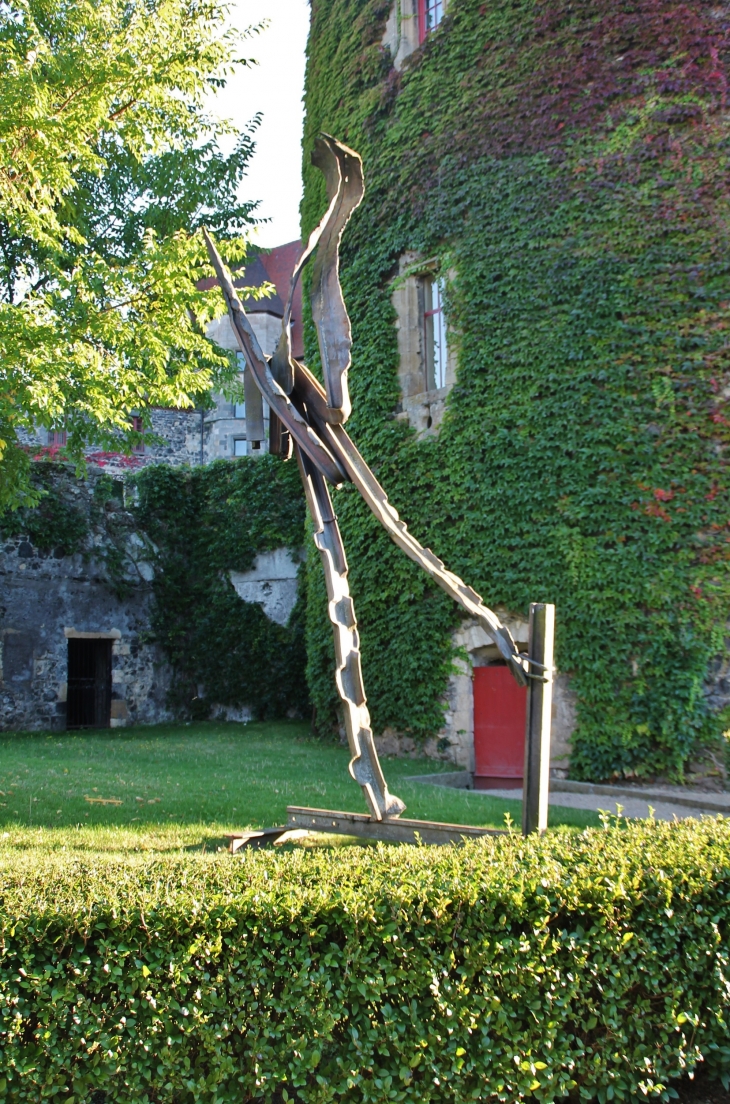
[{"x1": 203, "y1": 229, "x2": 348, "y2": 486}]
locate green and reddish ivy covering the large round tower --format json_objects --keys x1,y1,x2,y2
[{"x1": 303, "y1": 0, "x2": 730, "y2": 778}]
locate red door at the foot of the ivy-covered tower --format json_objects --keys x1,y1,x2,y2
[{"x1": 474, "y1": 667, "x2": 527, "y2": 789}]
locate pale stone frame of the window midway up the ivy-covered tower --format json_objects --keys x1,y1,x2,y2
[{"x1": 392, "y1": 253, "x2": 457, "y2": 436}]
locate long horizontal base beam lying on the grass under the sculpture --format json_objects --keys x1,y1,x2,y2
[{"x1": 286, "y1": 805, "x2": 505, "y2": 843}]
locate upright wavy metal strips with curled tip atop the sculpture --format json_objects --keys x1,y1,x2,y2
[{"x1": 272, "y1": 135, "x2": 364, "y2": 423}]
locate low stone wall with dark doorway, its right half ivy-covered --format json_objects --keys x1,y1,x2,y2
[{"x1": 0, "y1": 456, "x2": 310, "y2": 731}]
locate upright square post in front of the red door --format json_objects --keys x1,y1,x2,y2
[{"x1": 522, "y1": 602, "x2": 556, "y2": 836}]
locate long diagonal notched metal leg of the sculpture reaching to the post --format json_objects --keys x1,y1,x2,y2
[{"x1": 293, "y1": 361, "x2": 527, "y2": 686}]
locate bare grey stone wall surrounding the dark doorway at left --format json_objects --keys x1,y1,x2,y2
[{"x1": 0, "y1": 476, "x2": 170, "y2": 731}]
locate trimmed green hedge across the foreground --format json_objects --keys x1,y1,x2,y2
[{"x1": 0, "y1": 818, "x2": 730, "y2": 1104}]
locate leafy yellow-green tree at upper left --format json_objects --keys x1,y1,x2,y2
[{"x1": 0, "y1": 0, "x2": 261, "y2": 508}]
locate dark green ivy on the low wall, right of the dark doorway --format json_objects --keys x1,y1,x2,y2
[{"x1": 134, "y1": 456, "x2": 308, "y2": 720}]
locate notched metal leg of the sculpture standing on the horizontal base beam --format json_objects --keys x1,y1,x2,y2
[{"x1": 295, "y1": 446, "x2": 405, "y2": 820}]
